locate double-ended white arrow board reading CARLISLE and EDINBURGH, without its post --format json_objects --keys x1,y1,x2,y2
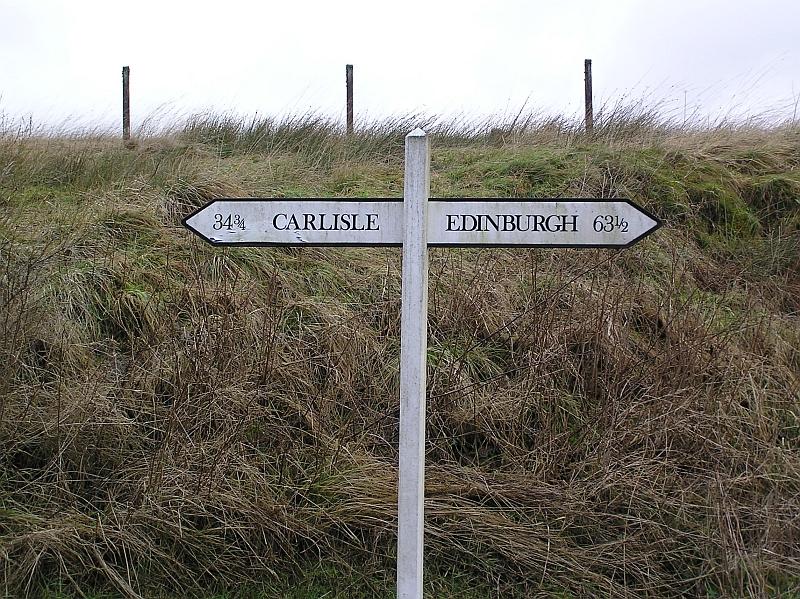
[{"x1": 183, "y1": 198, "x2": 661, "y2": 247}]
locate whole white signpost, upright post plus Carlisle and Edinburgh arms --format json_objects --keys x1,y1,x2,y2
[{"x1": 183, "y1": 129, "x2": 661, "y2": 599}]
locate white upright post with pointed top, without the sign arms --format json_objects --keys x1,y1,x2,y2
[{"x1": 397, "y1": 128, "x2": 430, "y2": 599}]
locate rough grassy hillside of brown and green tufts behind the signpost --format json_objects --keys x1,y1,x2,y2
[{"x1": 0, "y1": 117, "x2": 800, "y2": 598}]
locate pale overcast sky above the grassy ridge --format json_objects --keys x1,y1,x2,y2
[{"x1": 0, "y1": 0, "x2": 800, "y2": 131}]
